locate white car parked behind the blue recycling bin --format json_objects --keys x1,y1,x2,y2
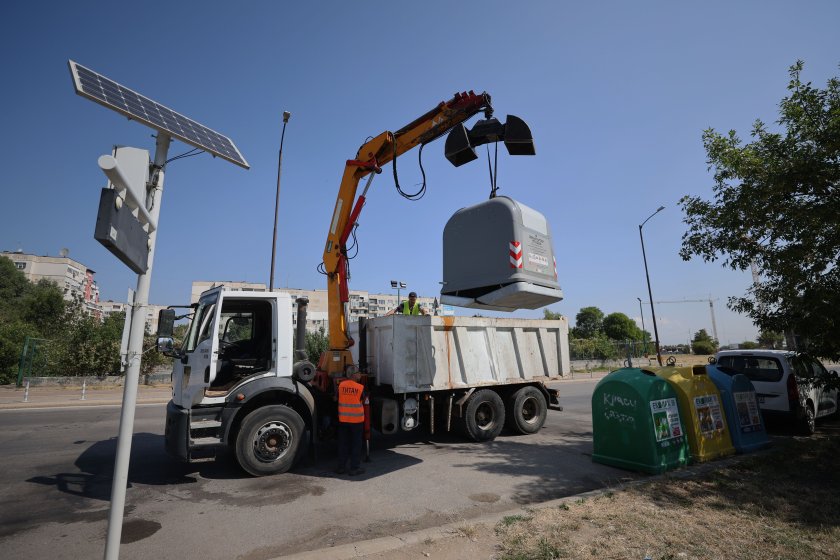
[{"x1": 715, "y1": 350, "x2": 838, "y2": 435}]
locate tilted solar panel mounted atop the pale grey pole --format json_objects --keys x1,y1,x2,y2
[{"x1": 68, "y1": 60, "x2": 250, "y2": 169}]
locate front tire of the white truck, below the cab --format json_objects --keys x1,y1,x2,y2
[{"x1": 234, "y1": 405, "x2": 304, "y2": 476}]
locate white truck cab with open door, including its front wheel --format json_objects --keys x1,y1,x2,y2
[{"x1": 166, "y1": 287, "x2": 315, "y2": 475}]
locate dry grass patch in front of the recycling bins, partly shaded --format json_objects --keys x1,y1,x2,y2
[{"x1": 496, "y1": 433, "x2": 840, "y2": 560}]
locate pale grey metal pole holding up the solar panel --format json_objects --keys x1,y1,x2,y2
[{"x1": 105, "y1": 132, "x2": 171, "y2": 560}]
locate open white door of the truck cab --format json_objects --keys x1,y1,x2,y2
[{"x1": 174, "y1": 289, "x2": 221, "y2": 408}]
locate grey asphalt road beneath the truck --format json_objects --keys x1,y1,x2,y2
[{"x1": 0, "y1": 380, "x2": 637, "y2": 560}]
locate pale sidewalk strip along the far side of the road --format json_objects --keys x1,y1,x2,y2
[{"x1": 0, "y1": 384, "x2": 172, "y2": 410}]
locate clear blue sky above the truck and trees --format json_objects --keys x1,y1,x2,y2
[{"x1": 0, "y1": 0, "x2": 840, "y2": 343}]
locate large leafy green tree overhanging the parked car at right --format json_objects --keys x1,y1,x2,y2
[{"x1": 680, "y1": 61, "x2": 840, "y2": 359}]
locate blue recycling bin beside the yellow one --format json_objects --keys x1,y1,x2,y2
[{"x1": 706, "y1": 365, "x2": 770, "y2": 453}]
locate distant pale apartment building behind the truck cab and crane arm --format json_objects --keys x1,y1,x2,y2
[{"x1": 190, "y1": 281, "x2": 435, "y2": 332}]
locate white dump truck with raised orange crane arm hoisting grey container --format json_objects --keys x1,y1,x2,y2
[{"x1": 158, "y1": 92, "x2": 569, "y2": 476}]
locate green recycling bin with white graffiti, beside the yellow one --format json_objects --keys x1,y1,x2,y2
[{"x1": 592, "y1": 368, "x2": 690, "y2": 474}]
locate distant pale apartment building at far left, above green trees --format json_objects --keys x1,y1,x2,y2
[{"x1": 0, "y1": 251, "x2": 99, "y2": 316}]
